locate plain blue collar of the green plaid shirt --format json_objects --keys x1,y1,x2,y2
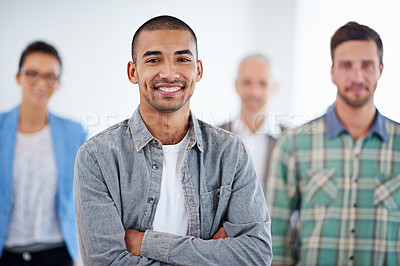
[{"x1": 325, "y1": 104, "x2": 387, "y2": 141}]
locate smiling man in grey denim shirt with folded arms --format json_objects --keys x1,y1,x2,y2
[{"x1": 75, "y1": 16, "x2": 272, "y2": 265}]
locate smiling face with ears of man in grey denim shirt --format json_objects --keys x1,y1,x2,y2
[{"x1": 128, "y1": 30, "x2": 203, "y2": 113}]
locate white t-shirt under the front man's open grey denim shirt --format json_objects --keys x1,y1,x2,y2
[{"x1": 153, "y1": 133, "x2": 189, "y2": 236}]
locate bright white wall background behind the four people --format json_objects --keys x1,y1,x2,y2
[{"x1": 0, "y1": 0, "x2": 400, "y2": 135}]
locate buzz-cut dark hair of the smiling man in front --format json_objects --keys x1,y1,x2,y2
[{"x1": 132, "y1": 15, "x2": 198, "y2": 63}]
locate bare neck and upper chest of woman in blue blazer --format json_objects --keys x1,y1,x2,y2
[{"x1": 18, "y1": 102, "x2": 47, "y2": 134}]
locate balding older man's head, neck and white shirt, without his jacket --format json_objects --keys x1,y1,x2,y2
[{"x1": 220, "y1": 55, "x2": 281, "y2": 192}]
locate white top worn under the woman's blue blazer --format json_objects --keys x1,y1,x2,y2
[{"x1": 5, "y1": 126, "x2": 63, "y2": 248}]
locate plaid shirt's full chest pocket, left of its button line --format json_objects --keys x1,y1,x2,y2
[{"x1": 305, "y1": 169, "x2": 338, "y2": 205}]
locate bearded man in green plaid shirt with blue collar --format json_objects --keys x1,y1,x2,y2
[{"x1": 266, "y1": 22, "x2": 400, "y2": 265}]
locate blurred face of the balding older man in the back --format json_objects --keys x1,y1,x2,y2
[{"x1": 236, "y1": 58, "x2": 272, "y2": 115}]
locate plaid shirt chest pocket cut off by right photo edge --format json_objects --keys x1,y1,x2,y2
[{"x1": 374, "y1": 175, "x2": 400, "y2": 211}]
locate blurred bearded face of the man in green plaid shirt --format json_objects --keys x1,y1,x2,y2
[{"x1": 331, "y1": 40, "x2": 383, "y2": 108}]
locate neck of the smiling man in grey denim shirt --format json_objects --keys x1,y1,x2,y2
[{"x1": 139, "y1": 106, "x2": 190, "y2": 145}]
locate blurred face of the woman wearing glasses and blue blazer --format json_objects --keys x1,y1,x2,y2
[{"x1": 16, "y1": 52, "x2": 61, "y2": 107}]
